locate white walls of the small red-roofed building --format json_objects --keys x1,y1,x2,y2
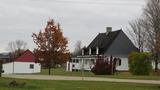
[{"x1": 3, "y1": 62, "x2": 41, "y2": 74}]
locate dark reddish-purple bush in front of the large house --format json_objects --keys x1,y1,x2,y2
[{"x1": 91, "y1": 58, "x2": 115, "y2": 75}]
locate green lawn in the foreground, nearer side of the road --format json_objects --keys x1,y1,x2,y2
[{"x1": 0, "y1": 78, "x2": 160, "y2": 90}]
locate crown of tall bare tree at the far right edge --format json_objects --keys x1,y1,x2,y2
[{"x1": 143, "y1": 0, "x2": 160, "y2": 54}]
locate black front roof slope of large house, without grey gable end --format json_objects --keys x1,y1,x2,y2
[{"x1": 87, "y1": 30, "x2": 122, "y2": 50}]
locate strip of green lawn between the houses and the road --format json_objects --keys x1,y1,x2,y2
[{"x1": 40, "y1": 68, "x2": 160, "y2": 80}]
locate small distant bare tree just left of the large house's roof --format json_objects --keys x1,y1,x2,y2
[{"x1": 73, "y1": 40, "x2": 82, "y2": 56}]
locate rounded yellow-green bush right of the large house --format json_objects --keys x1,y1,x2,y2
[{"x1": 129, "y1": 52, "x2": 152, "y2": 75}]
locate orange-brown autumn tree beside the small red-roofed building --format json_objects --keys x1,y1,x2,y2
[{"x1": 32, "y1": 19, "x2": 70, "y2": 75}]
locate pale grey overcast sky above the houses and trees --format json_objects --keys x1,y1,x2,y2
[{"x1": 0, "y1": 0, "x2": 145, "y2": 52}]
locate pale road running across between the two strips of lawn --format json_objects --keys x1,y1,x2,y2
[{"x1": 2, "y1": 75, "x2": 160, "y2": 84}]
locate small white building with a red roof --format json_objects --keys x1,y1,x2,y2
[{"x1": 3, "y1": 50, "x2": 41, "y2": 74}]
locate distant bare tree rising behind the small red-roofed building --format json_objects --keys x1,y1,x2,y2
[{"x1": 7, "y1": 40, "x2": 27, "y2": 60}]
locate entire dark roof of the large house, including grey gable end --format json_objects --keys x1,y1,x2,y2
[{"x1": 83, "y1": 29, "x2": 138, "y2": 56}]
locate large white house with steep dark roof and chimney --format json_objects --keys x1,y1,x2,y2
[{"x1": 66, "y1": 27, "x2": 138, "y2": 71}]
